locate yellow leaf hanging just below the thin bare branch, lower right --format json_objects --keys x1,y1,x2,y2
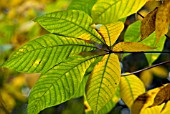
[{"x1": 120, "y1": 75, "x2": 145, "y2": 109}]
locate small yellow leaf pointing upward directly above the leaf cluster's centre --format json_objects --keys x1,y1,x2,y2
[{"x1": 98, "y1": 22, "x2": 124, "y2": 46}]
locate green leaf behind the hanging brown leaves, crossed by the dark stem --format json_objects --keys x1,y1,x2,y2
[{"x1": 141, "y1": 32, "x2": 166, "y2": 66}]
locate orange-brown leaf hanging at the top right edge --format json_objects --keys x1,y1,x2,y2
[{"x1": 155, "y1": 0, "x2": 170, "y2": 42}]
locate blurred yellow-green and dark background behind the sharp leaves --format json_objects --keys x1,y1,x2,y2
[{"x1": 0, "y1": 0, "x2": 170, "y2": 114}]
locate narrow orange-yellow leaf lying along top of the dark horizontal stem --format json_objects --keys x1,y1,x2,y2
[{"x1": 113, "y1": 42, "x2": 153, "y2": 52}]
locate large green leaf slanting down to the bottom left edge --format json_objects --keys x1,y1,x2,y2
[{"x1": 28, "y1": 56, "x2": 97, "y2": 114}]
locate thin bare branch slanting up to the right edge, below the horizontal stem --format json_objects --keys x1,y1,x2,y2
[{"x1": 121, "y1": 60, "x2": 170, "y2": 76}]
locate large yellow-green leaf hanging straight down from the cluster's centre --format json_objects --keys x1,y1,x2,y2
[{"x1": 86, "y1": 54, "x2": 121, "y2": 113}]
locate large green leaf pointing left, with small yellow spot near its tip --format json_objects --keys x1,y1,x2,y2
[{"x1": 4, "y1": 34, "x2": 95, "y2": 72}]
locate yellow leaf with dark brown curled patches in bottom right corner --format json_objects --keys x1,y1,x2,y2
[{"x1": 131, "y1": 84, "x2": 170, "y2": 114}]
